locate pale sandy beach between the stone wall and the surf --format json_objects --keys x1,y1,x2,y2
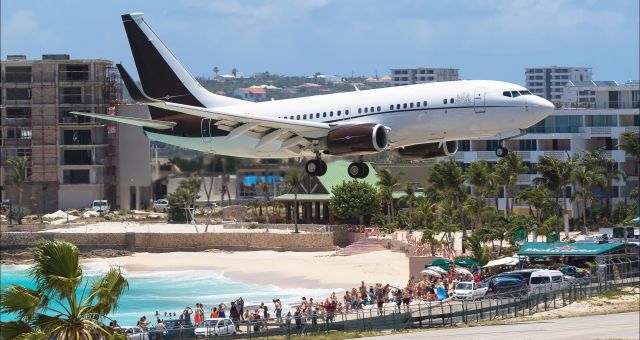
[{"x1": 84, "y1": 250, "x2": 409, "y2": 289}]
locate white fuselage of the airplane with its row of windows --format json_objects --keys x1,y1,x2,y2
[{"x1": 146, "y1": 80, "x2": 553, "y2": 158}]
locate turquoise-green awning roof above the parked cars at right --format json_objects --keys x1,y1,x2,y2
[{"x1": 518, "y1": 242, "x2": 625, "y2": 256}]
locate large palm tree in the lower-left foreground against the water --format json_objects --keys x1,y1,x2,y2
[{"x1": 0, "y1": 241, "x2": 129, "y2": 340}]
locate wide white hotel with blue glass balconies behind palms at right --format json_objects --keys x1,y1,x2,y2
[{"x1": 454, "y1": 83, "x2": 640, "y2": 217}]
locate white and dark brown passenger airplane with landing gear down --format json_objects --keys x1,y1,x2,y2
[{"x1": 72, "y1": 13, "x2": 554, "y2": 178}]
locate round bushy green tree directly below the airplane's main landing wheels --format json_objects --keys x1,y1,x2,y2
[{"x1": 329, "y1": 180, "x2": 382, "y2": 224}]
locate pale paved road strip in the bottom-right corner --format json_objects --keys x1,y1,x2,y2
[{"x1": 367, "y1": 312, "x2": 640, "y2": 340}]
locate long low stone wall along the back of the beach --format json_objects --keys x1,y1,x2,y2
[{"x1": 0, "y1": 232, "x2": 335, "y2": 252}]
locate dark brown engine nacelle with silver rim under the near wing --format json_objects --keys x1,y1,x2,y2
[{"x1": 325, "y1": 123, "x2": 389, "y2": 155}]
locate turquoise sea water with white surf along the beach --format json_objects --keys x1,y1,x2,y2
[{"x1": 0, "y1": 263, "x2": 340, "y2": 326}]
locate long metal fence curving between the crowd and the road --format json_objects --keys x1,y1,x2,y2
[{"x1": 122, "y1": 260, "x2": 640, "y2": 340}]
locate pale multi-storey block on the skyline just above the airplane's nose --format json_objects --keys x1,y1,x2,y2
[{"x1": 524, "y1": 65, "x2": 592, "y2": 102}]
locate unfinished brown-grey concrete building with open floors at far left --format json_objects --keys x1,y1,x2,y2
[{"x1": 0, "y1": 54, "x2": 121, "y2": 213}]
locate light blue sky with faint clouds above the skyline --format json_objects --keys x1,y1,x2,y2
[{"x1": 0, "y1": 0, "x2": 640, "y2": 84}]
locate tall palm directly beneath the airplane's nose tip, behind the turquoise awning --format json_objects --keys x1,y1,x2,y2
[{"x1": 533, "y1": 155, "x2": 575, "y2": 234}]
